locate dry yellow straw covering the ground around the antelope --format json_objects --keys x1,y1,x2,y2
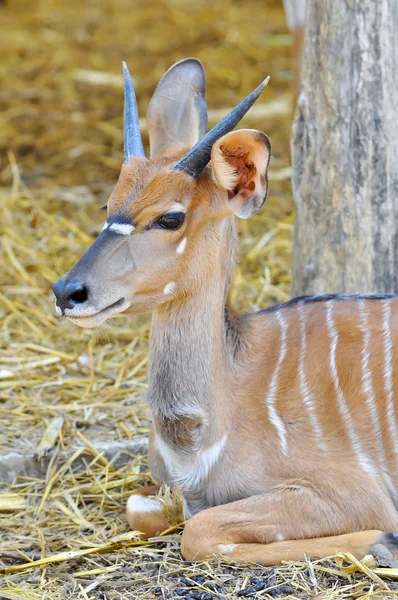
[{"x1": 0, "y1": 0, "x2": 394, "y2": 600}]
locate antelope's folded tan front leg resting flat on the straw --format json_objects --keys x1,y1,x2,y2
[{"x1": 181, "y1": 487, "x2": 398, "y2": 565}]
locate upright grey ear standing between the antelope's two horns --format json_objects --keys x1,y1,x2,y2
[{"x1": 148, "y1": 58, "x2": 207, "y2": 158}]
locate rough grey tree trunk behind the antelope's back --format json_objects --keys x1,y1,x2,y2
[{"x1": 292, "y1": 0, "x2": 398, "y2": 296}]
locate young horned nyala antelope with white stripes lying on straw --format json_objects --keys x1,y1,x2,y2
[{"x1": 54, "y1": 58, "x2": 398, "y2": 565}]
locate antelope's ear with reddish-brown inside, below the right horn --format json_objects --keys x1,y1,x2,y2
[{"x1": 211, "y1": 129, "x2": 271, "y2": 219}]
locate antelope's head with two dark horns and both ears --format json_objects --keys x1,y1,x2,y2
[{"x1": 53, "y1": 58, "x2": 270, "y2": 327}]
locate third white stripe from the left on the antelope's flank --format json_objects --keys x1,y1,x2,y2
[{"x1": 326, "y1": 300, "x2": 377, "y2": 475}]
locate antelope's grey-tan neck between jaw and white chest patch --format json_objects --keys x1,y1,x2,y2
[{"x1": 149, "y1": 278, "x2": 239, "y2": 447}]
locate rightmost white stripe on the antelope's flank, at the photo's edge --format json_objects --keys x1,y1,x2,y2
[{"x1": 382, "y1": 300, "x2": 398, "y2": 455}]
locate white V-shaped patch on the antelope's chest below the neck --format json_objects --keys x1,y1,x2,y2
[{"x1": 155, "y1": 433, "x2": 228, "y2": 490}]
